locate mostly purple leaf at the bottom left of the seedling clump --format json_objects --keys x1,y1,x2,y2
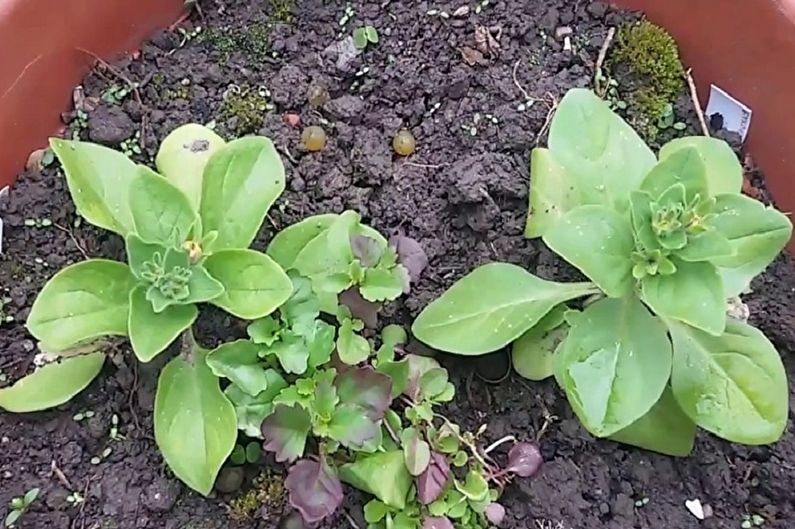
[{"x1": 284, "y1": 459, "x2": 342, "y2": 524}]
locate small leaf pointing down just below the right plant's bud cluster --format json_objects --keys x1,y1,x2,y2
[{"x1": 641, "y1": 259, "x2": 726, "y2": 336}]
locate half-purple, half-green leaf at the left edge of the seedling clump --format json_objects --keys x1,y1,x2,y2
[{"x1": 262, "y1": 404, "x2": 312, "y2": 463}]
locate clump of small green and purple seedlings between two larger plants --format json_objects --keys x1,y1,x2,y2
[{"x1": 207, "y1": 211, "x2": 541, "y2": 529}]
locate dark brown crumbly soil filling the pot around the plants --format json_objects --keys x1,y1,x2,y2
[{"x1": 0, "y1": 0, "x2": 795, "y2": 529}]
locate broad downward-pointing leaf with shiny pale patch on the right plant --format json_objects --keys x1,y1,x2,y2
[{"x1": 555, "y1": 296, "x2": 671, "y2": 437}]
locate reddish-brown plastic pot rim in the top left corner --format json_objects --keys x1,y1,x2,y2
[{"x1": 0, "y1": 0, "x2": 184, "y2": 188}]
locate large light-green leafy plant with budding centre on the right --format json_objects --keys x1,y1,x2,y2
[{"x1": 412, "y1": 89, "x2": 792, "y2": 456}]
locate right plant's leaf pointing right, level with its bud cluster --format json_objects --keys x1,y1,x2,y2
[{"x1": 709, "y1": 194, "x2": 792, "y2": 297}]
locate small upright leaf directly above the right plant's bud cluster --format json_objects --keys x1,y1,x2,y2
[{"x1": 640, "y1": 147, "x2": 709, "y2": 200}]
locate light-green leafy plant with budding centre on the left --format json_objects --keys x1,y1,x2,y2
[{"x1": 0, "y1": 125, "x2": 292, "y2": 494}]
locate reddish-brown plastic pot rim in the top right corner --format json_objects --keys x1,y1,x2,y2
[{"x1": 612, "y1": 0, "x2": 795, "y2": 253}]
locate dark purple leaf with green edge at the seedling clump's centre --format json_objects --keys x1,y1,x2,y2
[{"x1": 334, "y1": 366, "x2": 392, "y2": 421}]
